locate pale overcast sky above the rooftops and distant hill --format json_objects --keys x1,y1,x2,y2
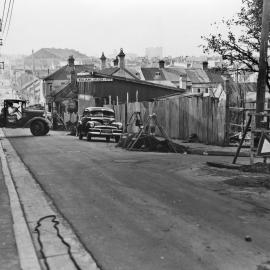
[{"x1": 0, "y1": 0, "x2": 241, "y2": 56}]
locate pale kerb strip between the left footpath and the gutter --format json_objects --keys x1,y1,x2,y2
[{"x1": 0, "y1": 129, "x2": 41, "y2": 270}]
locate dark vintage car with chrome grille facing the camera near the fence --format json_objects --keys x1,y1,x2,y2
[{"x1": 77, "y1": 107, "x2": 123, "y2": 142}]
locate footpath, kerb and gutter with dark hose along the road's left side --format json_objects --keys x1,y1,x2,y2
[{"x1": 0, "y1": 129, "x2": 99, "y2": 270}]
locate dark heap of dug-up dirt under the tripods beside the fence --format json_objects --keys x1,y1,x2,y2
[{"x1": 117, "y1": 134, "x2": 188, "y2": 153}]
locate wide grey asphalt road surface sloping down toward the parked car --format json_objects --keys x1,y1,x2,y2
[{"x1": 6, "y1": 130, "x2": 270, "y2": 270}]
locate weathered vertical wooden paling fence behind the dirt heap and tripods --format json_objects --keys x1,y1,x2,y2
[{"x1": 112, "y1": 96, "x2": 226, "y2": 145}]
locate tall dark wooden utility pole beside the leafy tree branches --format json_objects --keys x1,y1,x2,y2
[{"x1": 256, "y1": 0, "x2": 270, "y2": 127}]
